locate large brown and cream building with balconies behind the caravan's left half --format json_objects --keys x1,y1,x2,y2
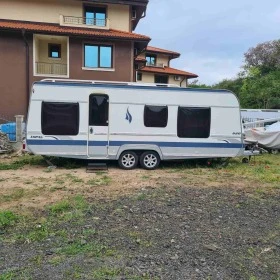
[{"x1": 0, "y1": 0, "x2": 150, "y2": 121}]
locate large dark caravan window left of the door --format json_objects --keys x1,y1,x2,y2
[{"x1": 41, "y1": 102, "x2": 80, "y2": 136}]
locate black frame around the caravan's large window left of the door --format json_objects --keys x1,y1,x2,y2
[{"x1": 41, "y1": 101, "x2": 80, "y2": 136}]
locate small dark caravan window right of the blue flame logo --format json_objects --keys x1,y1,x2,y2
[{"x1": 144, "y1": 105, "x2": 168, "y2": 128}]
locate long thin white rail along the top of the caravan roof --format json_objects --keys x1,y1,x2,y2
[{"x1": 41, "y1": 79, "x2": 179, "y2": 87}]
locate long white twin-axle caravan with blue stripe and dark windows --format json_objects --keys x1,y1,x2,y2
[{"x1": 26, "y1": 80, "x2": 244, "y2": 169}]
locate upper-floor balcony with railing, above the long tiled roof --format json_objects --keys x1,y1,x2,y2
[{"x1": 60, "y1": 15, "x2": 110, "y2": 30}]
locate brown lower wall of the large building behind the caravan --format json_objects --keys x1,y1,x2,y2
[{"x1": 0, "y1": 30, "x2": 133, "y2": 120}]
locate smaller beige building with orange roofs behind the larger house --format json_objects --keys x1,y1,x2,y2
[{"x1": 135, "y1": 46, "x2": 198, "y2": 87}]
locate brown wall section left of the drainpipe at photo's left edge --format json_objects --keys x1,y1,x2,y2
[{"x1": 0, "y1": 31, "x2": 27, "y2": 120}]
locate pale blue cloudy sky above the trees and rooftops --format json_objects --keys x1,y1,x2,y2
[{"x1": 135, "y1": 0, "x2": 280, "y2": 85}]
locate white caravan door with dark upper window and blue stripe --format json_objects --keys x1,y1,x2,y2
[{"x1": 88, "y1": 94, "x2": 109, "y2": 159}]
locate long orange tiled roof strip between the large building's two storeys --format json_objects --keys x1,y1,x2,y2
[{"x1": 0, "y1": 20, "x2": 151, "y2": 41}]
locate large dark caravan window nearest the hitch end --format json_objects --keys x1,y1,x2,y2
[{"x1": 177, "y1": 106, "x2": 212, "y2": 139}]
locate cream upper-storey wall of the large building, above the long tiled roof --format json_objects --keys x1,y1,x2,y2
[{"x1": 0, "y1": 0, "x2": 131, "y2": 31}]
